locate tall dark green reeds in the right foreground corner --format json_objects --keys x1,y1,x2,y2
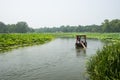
[{"x1": 87, "y1": 43, "x2": 120, "y2": 80}]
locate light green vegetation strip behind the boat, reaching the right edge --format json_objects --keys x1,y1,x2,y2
[{"x1": 50, "y1": 32, "x2": 120, "y2": 41}]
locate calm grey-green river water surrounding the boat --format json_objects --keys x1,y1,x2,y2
[{"x1": 0, "y1": 38, "x2": 103, "y2": 80}]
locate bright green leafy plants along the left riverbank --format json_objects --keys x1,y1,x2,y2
[{"x1": 0, "y1": 34, "x2": 53, "y2": 52}]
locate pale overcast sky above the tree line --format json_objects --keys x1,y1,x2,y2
[{"x1": 0, "y1": 0, "x2": 120, "y2": 28}]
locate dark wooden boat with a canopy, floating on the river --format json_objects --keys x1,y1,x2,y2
[{"x1": 75, "y1": 35, "x2": 87, "y2": 48}]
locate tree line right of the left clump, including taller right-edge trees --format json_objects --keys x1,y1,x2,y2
[{"x1": 35, "y1": 19, "x2": 120, "y2": 32}]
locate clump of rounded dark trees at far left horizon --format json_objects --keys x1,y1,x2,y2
[{"x1": 0, "y1": 22, "x2": 34, "y2": 33}]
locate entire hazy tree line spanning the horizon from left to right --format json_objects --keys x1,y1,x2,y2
[{"x1": 0, "y1": 19, "x2": 120, "y2": 33}]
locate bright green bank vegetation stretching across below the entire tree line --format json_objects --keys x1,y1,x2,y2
[{"x1": 0, "y1": 32, "x2": 120, "y2": 52}]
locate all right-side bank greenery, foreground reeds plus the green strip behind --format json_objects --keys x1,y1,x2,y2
[{"x1": 81, "y1": 33, "x2": 120, "y2": 80}]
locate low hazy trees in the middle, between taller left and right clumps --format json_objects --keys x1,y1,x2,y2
[{"x1": 35, "y1": 25, "x2": 101, "y2": 32}]
